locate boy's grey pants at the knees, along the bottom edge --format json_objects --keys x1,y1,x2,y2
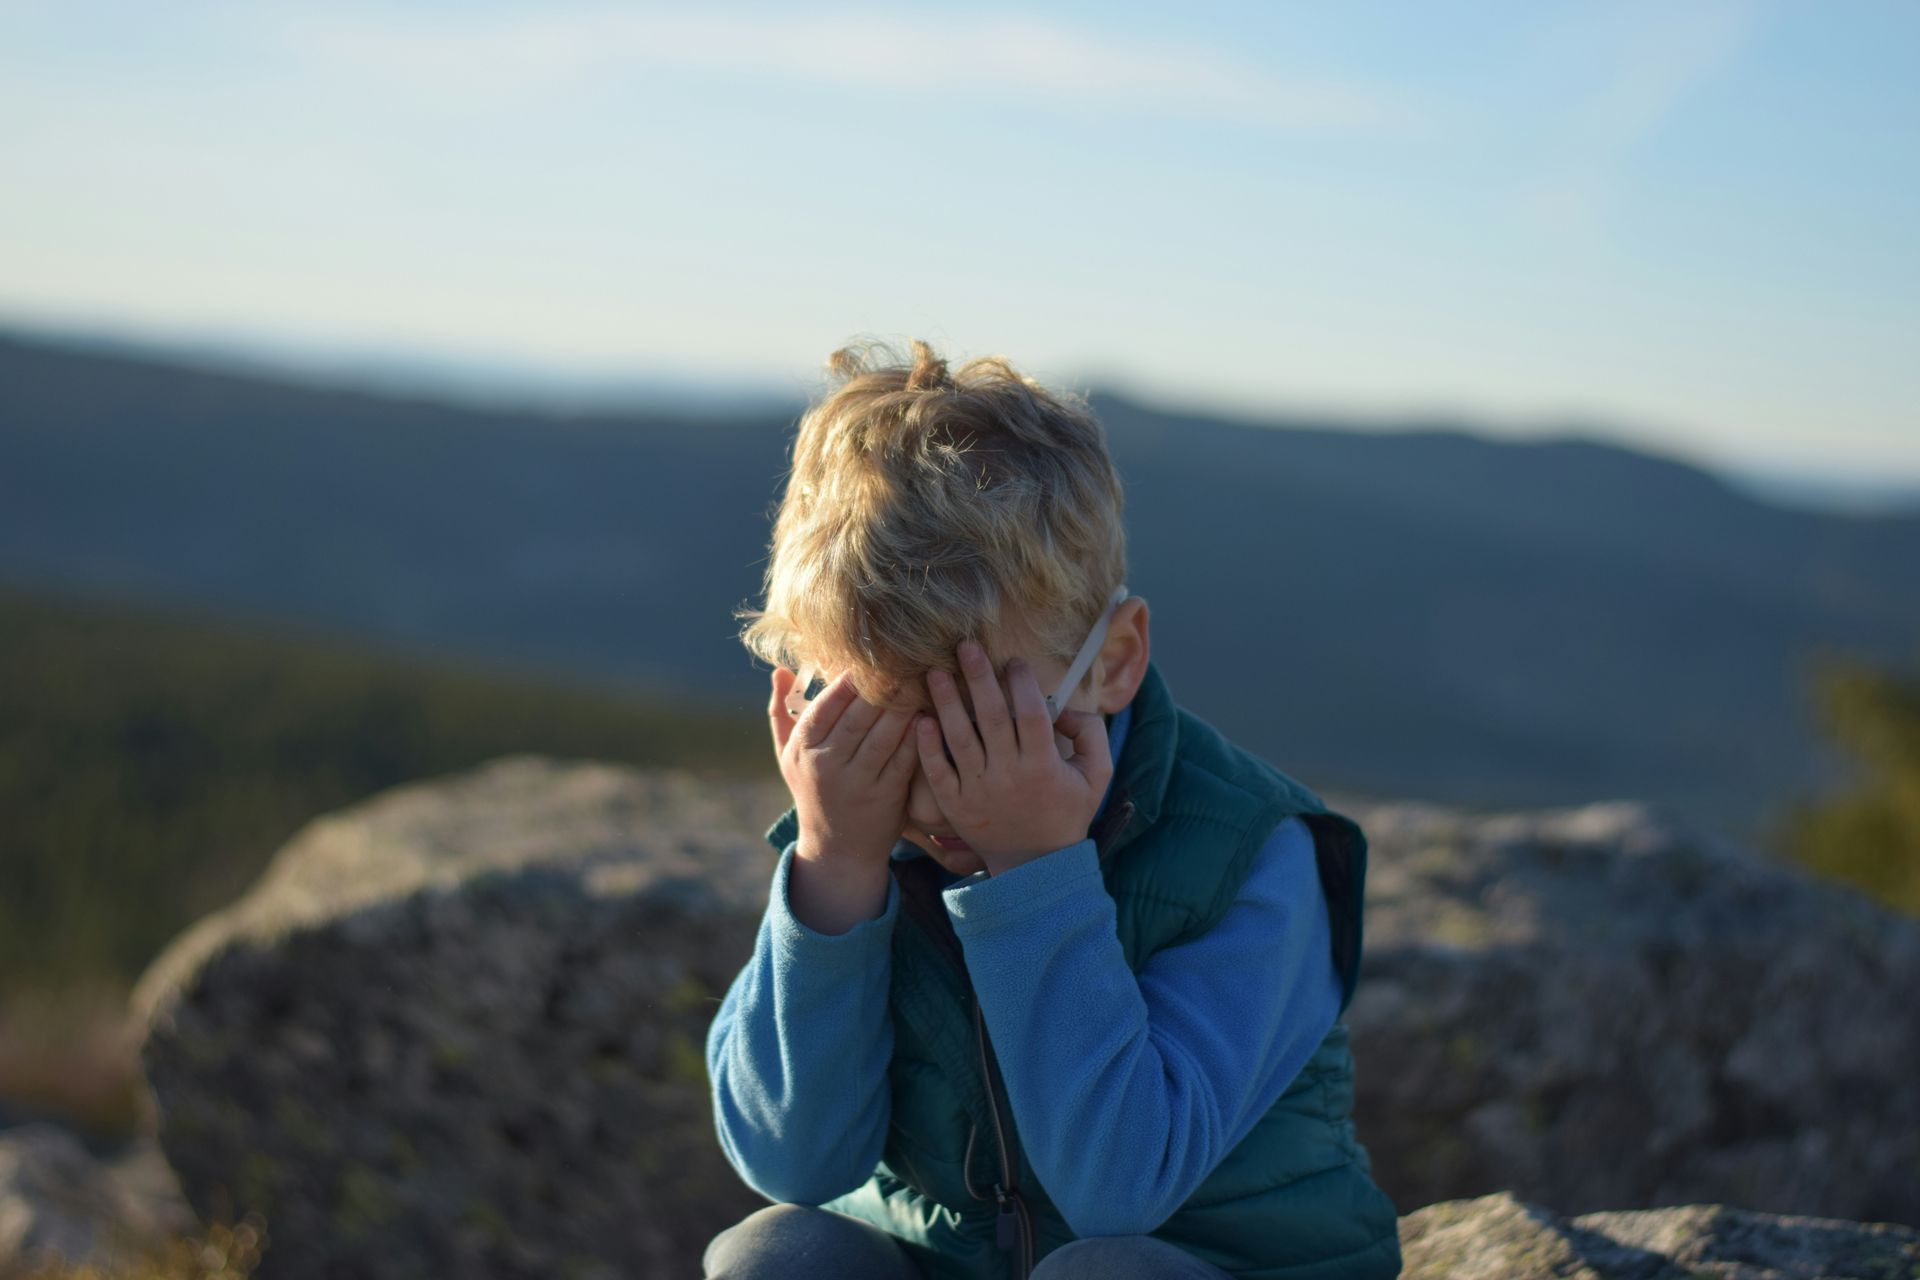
[{"x1": 701, "y1": 1205, "x2": 1233, "y2": 1280}]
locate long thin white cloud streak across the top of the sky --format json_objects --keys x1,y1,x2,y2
[{"x1": 275, "y1": 8, "x2": 1430, "y2": 134}]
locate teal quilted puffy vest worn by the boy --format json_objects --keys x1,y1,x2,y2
[{"x1": 766, "y1": 662, "x2": 1402, "y2": 1280}]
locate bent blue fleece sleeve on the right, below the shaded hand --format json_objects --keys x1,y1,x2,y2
[{"x1": 945, "y1": 818, "x2": 1340, "y2": 1236}]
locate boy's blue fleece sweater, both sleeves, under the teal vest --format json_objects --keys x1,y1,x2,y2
[{"x1": 707, "y1": 694, "x2": 1340, "y2": 1236}]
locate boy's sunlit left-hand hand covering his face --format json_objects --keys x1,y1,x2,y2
[{"x1": 768, "y1": 668, "x2": 914, "y2": 871}]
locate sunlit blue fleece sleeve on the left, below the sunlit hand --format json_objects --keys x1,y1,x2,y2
[{"x1": 707, "y1": 844, "x2": 900, "y2": 1205}]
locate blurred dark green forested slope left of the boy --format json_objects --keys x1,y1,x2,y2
[{"x1": 0, "y1": 587, "x2": 774, "y2": 1136}]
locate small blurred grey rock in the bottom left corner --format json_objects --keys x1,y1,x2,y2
[{"x1": 0, "y1": 1123, "x2": 192, "y2": 1276}]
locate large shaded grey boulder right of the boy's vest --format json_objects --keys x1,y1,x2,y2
[{"x1": 1329, "y1": 798, "x2": 1920, "y2": 1222}]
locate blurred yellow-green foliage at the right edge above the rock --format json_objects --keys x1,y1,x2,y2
[{"x1": 1774, "y1": 644, "x2": 1920, "y2": 915}]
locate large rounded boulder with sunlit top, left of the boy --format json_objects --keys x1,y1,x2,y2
[{"x1": 134, "y1": 756, "x2": 789, "y2": 1280}]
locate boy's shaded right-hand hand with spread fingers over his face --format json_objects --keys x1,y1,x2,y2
[{"x1": 914, "y1": 641, "x2": 1114, "y2": 875}]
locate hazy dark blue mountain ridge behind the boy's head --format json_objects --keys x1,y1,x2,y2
[{"x1": 0, "y1": 328, "x2": 1920, "y2": 852}]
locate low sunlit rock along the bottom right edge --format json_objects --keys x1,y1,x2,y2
[{"x1": 1400, "y1": 1192, "x2": 1920, "y2": 1280}]
